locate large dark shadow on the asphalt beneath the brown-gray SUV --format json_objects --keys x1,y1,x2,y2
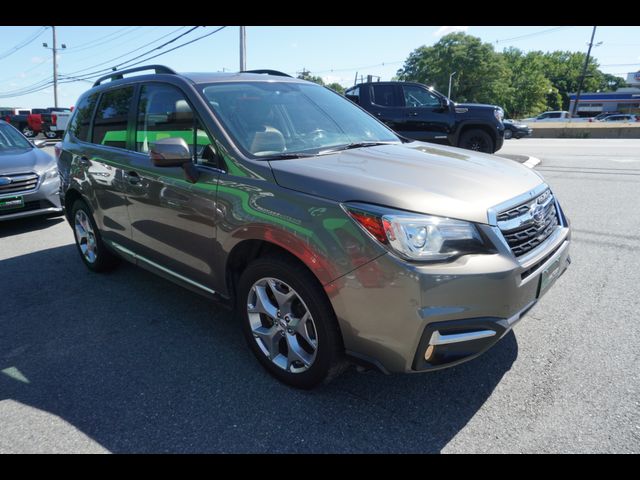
[{"x1": 0, "y1": 245, "x2": 518, "y2": 452}]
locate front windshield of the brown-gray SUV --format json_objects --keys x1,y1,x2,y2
[{"x1": 203, "y1": 82, "x2": 400, "y2": 157}]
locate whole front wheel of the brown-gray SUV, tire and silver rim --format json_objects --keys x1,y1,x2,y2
[{"x1": 237, "y1": 256, "x2": 345, "y2": 389}]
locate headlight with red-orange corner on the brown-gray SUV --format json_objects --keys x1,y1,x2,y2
[{"x1": 343, "y1": 204, "x2": 491, "y2": 261}]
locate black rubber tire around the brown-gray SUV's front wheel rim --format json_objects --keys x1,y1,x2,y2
[{"x1": 236, "y1": 257, "x2": 342, "y2": 389}]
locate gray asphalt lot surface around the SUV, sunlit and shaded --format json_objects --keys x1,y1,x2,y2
[{"x1": 0, "y1": 139, "x2": 640, "y2": 453}]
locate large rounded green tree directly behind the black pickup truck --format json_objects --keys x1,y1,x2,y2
[{"x1": 397, "y1": 33, "x2": 513, "y2": 105}]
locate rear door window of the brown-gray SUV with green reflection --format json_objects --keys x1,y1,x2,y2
[{"x1": 92, "y1": 87, "x2": 133, "y2": 148}]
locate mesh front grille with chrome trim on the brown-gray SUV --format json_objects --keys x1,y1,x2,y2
[{"x1": 498, "y1": 190, "x2": 559, "y2": 257}]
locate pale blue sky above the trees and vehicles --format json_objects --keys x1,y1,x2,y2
[{"x1": 0, "y1": 26, "x2": 640, "y2": 108}]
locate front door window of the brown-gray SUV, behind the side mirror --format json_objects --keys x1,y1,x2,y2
[{"x1": 136, "y1": 84, "x2": 212, "y2": 163}]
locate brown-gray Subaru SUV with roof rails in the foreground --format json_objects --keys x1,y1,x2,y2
[{"x1": 58, "y1": 66, "x2": 570, "y2": 388}]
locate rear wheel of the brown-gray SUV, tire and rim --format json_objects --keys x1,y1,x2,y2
[{"x1": 71, "y1": 199, "x2": 119, "y2": 272}]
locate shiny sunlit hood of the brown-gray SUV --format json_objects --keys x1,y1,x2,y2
[{"x1": 270, "y1": 142, "x2": 543, "y2": 223}]
